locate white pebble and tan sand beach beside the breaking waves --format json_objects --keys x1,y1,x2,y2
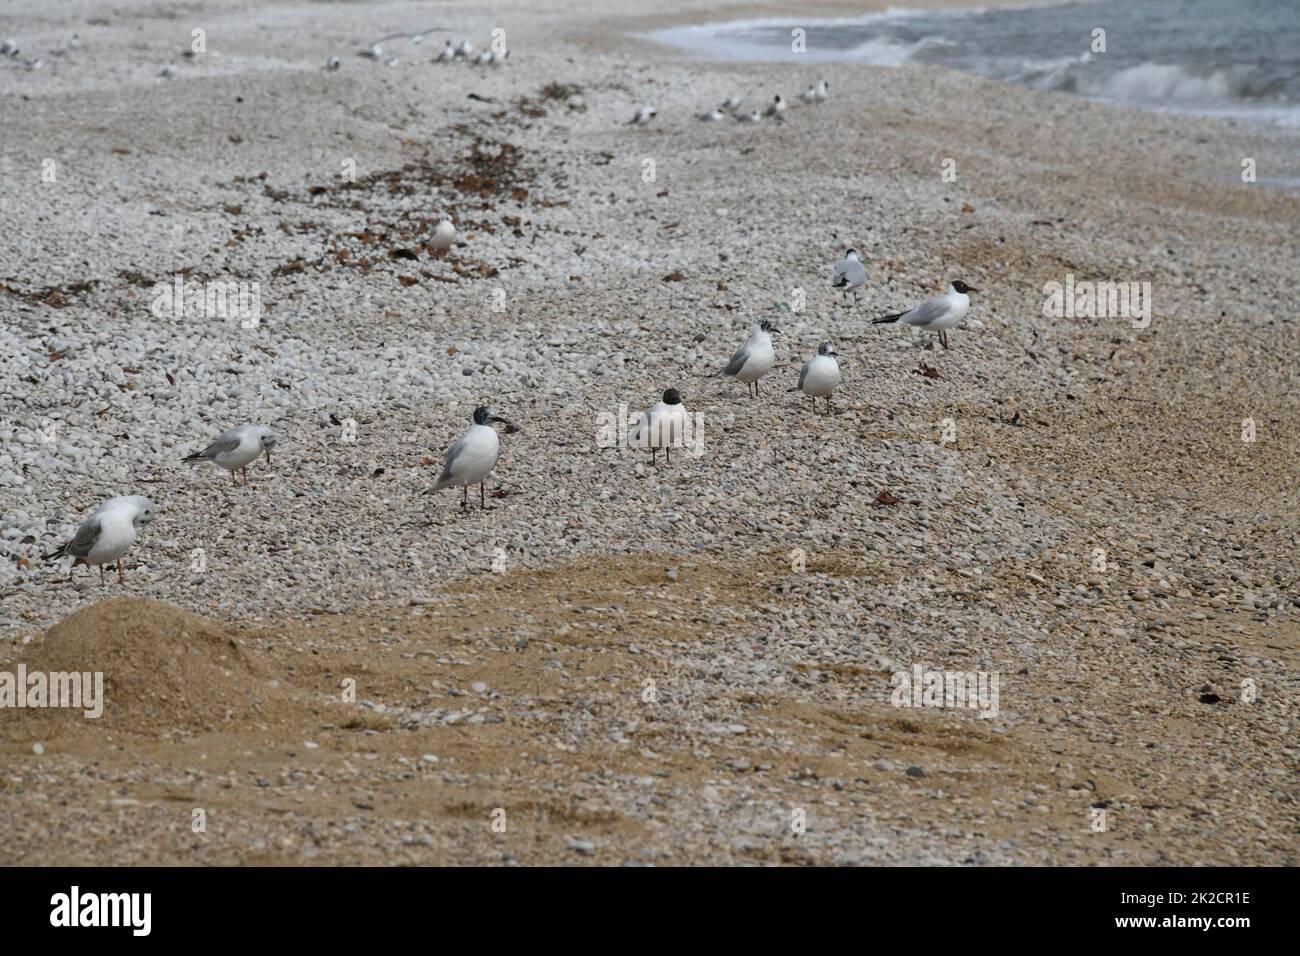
[{"x1": 0, "y1": 0, "x2": 1300, "y2": 865}]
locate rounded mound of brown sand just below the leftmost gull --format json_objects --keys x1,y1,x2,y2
[{"x1": 0, "y1": 598, "x2": 285, "y2": 737}]
